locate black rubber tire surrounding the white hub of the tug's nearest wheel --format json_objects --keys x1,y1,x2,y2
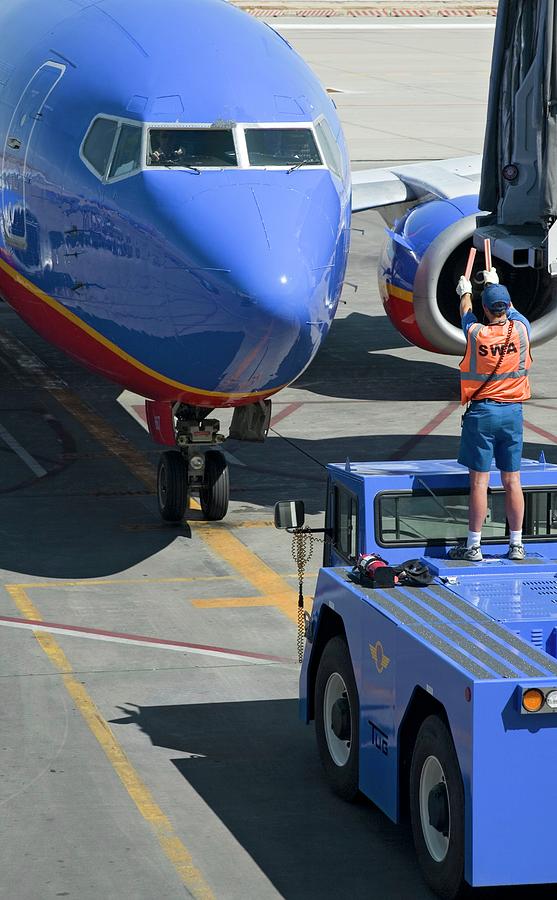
[{"x1": 410, "y1": 716, "x2": 468, "y2": 900}]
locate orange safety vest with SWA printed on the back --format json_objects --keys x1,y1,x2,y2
[{"x1": 460, "y1": 319, "x2": 532, "y2": 404}]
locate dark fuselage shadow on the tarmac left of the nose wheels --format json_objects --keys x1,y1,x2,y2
[{"x1": 0, "y1": 308, "x2": 190, "y2": 580}]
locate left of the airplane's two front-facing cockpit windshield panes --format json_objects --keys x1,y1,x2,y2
[{"x1": 147, "y1": 128, "x2": 238, "y2": 168}]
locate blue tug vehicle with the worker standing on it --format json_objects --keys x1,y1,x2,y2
[{"x1": 275, "y1": 455, "x2": 557, "y2": 900}]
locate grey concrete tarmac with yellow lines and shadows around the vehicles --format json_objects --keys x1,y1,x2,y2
[{"x1": 0, "y1": 15, "x2": 557, "y2": 900}]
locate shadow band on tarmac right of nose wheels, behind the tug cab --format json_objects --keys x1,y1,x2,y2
[{"x1": 232, "y1": 434, "x2": 557, "y2": 515}]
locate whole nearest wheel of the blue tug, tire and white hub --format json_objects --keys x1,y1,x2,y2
[{"x1": 410, "y1": 716, "x2": 466, "y2": 900}]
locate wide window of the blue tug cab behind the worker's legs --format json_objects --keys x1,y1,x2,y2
[{"x1": 375, "y1": 489, "x2": 557, "y2": 547}]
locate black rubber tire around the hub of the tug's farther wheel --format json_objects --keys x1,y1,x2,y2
[{"x1": 315, "y1": 636, "x2": 360, "y2": 802}]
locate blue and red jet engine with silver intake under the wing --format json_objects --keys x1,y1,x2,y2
[{"x1": 378, "y1": 195, "x2": 557, "y2": 356}]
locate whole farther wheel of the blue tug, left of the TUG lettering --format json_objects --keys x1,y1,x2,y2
[{"x1": 315, "y1": 637, "x2": 360, "y2": 801}]
